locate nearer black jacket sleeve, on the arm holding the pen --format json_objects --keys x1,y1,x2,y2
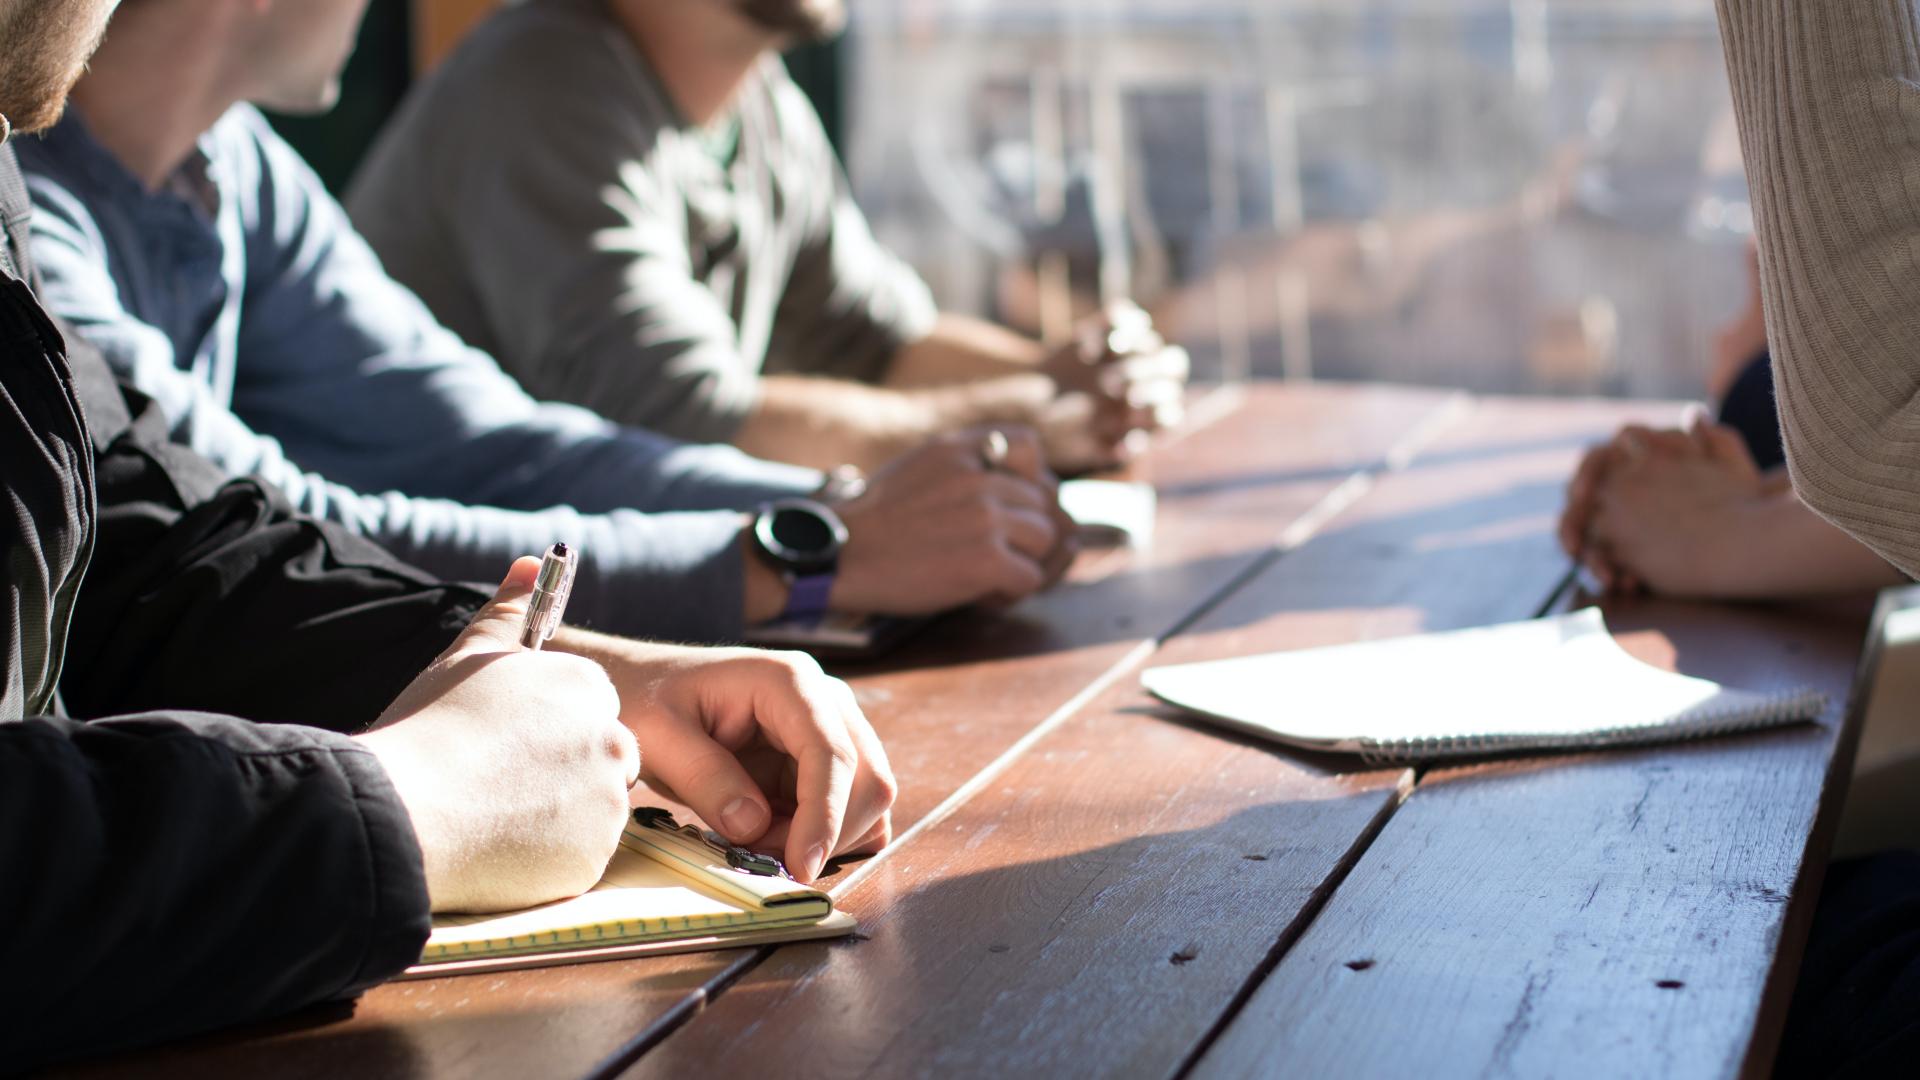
[{"x1": 0, "y1": 713, "x2": 428, "y2": 1072}]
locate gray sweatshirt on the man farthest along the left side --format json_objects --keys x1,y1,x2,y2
[{"x1": 348, "y1": 0, "x2": 935, "y2": 442}]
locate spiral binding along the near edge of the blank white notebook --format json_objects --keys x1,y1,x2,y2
[{"x1": 1359, "y1": 686, "x2": 1828, "y2": 765}]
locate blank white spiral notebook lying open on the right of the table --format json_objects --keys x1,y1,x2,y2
[{"x1": 1140, "y1": 607, "x2": 1826, "y2": 761}]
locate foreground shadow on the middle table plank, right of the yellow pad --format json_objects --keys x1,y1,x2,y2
[{"x1": 643, "y1": 795, "x2": 1392, "y2": 1076}]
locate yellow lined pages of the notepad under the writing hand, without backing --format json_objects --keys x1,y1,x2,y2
[{"x1": 420, "y1": 814, "x2": 833, "y2": 949}]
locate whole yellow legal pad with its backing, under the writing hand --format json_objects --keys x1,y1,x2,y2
[{"x1": 407, "y1": 811, "x2": 854, "y2": 978}]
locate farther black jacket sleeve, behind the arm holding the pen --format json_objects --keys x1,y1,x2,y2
[{"x1": 60, "y1": 334, "x2": 487, "y2": 732}]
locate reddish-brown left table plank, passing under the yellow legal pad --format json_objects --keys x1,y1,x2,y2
[{"x1": 71, "y1": 386, "x2": 1448, "y2": 1076}]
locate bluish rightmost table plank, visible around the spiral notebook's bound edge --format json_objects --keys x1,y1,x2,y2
[{"x1": 1194, "y1": 603, "x2": 1864, "y2": 1078}]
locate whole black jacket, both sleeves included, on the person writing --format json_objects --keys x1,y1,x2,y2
[{"x1": 0, "y1": 146, "x2": 451, "y2": 1072}]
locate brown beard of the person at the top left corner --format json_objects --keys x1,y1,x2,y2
[{"x1": 0, "y1": 0, "x2": 113, "y2": 131}]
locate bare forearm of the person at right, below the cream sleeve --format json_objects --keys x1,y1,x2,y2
[{"x1": 1715, "y1": 492, "x2": 1907, "y2": 600}]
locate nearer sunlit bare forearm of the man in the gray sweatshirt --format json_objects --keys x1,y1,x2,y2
[{"x1": 735, "y1": 373, "x2": 1052, "y2": 471}]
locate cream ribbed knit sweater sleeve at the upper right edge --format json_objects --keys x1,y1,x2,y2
[{"x1": 1716, "y1": 0, "x2": 1920, "y2": 575}]
